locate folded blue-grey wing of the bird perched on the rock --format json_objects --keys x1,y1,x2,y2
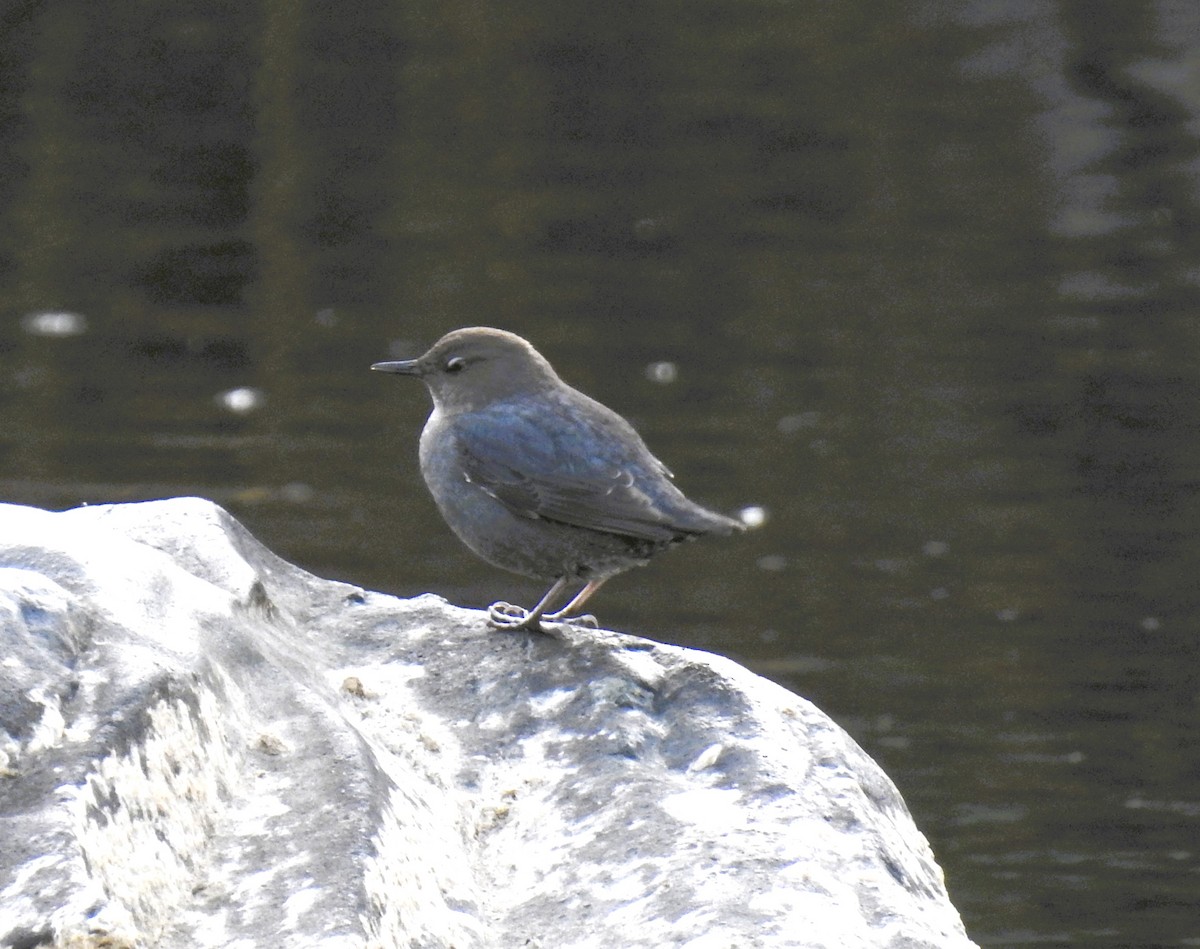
[{"x1": 454, "y1": 404, "x2": 713, "y2": 541}]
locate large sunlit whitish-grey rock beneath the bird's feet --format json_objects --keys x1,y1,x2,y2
[{"x1": 0, "y1": 499, "x2": 972, "y2": 949}]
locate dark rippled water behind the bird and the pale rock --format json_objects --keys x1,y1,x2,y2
[{"x1": 0, "y1": 0, "x2": 1200, "y2": 947}]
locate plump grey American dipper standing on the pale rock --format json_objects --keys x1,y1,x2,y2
[{"x1": 371, "y1": 328, "x2": 743, "y2": 631}]
